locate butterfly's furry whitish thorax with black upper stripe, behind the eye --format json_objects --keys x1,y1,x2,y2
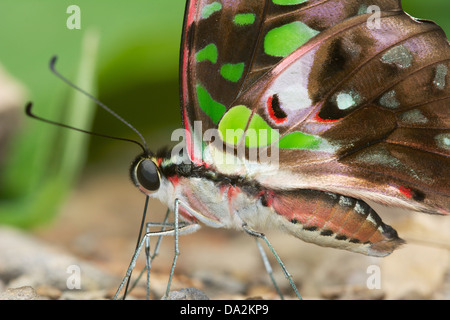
[{"x1": 154, "y1": 151, "x2": 263, "y2": 228}]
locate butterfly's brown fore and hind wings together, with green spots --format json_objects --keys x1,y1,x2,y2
[{"x1": 181, "y1": 1, "x2": 450, "y2": 213}]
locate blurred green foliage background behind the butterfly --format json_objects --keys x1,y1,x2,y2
[{"x1": 0, "y1": 0, "x2": 450, "y2": 227}]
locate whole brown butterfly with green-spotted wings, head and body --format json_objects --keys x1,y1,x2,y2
[{"x1": 132, "y1": 0, "x2": 450, "y2": 268}]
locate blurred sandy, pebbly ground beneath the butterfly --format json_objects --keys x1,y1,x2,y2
[{"x1": 0, "y1": 165, "x2": 450, "y2": 299}]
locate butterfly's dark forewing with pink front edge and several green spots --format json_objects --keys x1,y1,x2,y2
[{"x1": 180, "y1": 0, "x2": 400, "y2": 163}]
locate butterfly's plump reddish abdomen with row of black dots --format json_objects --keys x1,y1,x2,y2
[{"x1": 263, "y1": 190, "x2": 403, "y2": 256}]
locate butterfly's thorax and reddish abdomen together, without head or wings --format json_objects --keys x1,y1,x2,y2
[{"x1": 140, "y1": 150, "x2": 403, "y2": 256}]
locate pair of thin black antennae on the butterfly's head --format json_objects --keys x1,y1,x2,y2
[{"x1": 25, "y1": 56, "x2": 149, "y2": 155}]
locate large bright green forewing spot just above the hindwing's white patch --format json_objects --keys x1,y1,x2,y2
[{"x1": 264, "y1": 21, "x2": 319, "y2": 57}]
